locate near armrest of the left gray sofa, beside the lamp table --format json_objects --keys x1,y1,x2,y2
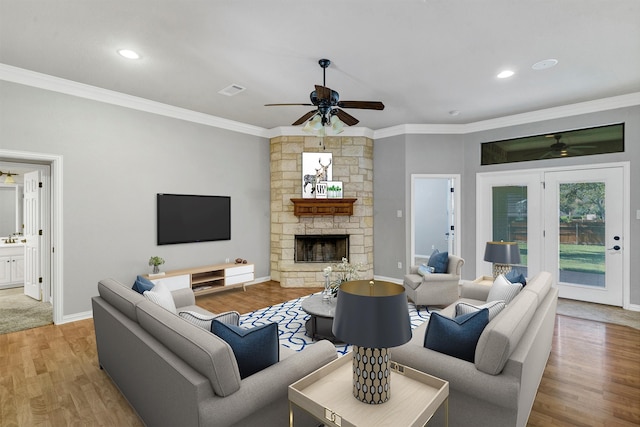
[{"x1": 201, "y1": 340, "x2": 337, "y2": 426}]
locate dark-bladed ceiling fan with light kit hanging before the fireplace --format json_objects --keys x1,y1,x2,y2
[{"x1": 265, "y1": 59, "x2": 384, "y2": 129}]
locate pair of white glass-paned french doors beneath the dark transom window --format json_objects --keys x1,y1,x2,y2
[{"x1": 476, "y1": 165, "x2": 629, "y2": 306}]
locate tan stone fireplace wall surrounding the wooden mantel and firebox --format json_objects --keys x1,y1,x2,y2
[{"x1": 271, "y1": 136, "x2": 373, "y2": 287}]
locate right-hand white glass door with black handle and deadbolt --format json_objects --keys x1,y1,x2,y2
[{"x1": 544, "y1": 167, "x2": 625, "y2": 306}]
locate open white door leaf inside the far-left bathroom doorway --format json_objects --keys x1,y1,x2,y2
[{"x1": 24, "y1": 171, "x2": 42, "y2": 301}]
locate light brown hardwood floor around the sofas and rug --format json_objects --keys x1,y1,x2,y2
[{"x1": 0, "y1": 282, "x2": 640, "y2": 427}]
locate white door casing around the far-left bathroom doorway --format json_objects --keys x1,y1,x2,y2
[{"x1": 0, "y1": 149, "x2": 64, "y2": 324}]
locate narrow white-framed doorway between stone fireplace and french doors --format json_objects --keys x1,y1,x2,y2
[{"x1": 410, "y1": 174, "x2": 460, "y2": 265}]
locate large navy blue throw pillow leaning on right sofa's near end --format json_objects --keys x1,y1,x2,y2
[{"x1": 424, "y1": 308, "x2": 489, "y2": 363}]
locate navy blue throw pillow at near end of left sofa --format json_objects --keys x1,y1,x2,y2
[{"x1": 211, "y1": 319, "x2": 280, "y2": 378}]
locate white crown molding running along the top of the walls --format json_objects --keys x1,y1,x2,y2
[{"x1": 0, "y1": 64, "x2": 640, "y2": 139}]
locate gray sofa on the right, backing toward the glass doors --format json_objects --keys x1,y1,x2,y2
[{"x1": 391, "y1": 272, "x2": 558, "y2": 427}]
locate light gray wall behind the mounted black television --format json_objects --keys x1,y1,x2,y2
[{"x1": 0, "y1": 81, "x2": 270, "y2": 315}]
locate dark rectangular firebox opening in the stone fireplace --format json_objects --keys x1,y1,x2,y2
[{"x1": 294, "y1": 234, "x2": 349, "y2": 262}]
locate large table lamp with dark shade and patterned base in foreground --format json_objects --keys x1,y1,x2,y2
[{"x1": 332, "y1": 280, "x2": 411, "y2": 404}]
